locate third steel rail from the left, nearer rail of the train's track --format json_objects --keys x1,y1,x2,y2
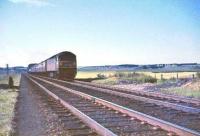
[{"x1": 36, "y1": 75, "x2": 200, "y2": 114}]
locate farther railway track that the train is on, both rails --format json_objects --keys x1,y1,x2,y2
[{"x1": 37, "y1": 77, "x2": 200, "y2": 110}]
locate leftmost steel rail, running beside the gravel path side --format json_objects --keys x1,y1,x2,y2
[{"x1": 27, "y1": 76, "x2": 117, "y2": 136}]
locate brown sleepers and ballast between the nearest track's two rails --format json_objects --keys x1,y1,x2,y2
[{"x1": 31, "y1": 79, "x2": 169, "y2": 136}]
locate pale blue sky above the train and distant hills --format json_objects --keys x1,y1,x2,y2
[{"x1": 0, "y1": 0, "x2": 200, "y2": 67}]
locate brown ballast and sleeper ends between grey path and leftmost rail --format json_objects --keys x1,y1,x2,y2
[{"x1": 24, "y1": 77, "x2": 98, "y2": 136}]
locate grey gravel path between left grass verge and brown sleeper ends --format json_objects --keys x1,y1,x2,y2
[{"x1": 14, "y1": 76, "x2": 63, "y2": 136}]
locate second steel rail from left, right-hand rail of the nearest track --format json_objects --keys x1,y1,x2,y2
[{"x1": 31, "y1": 76, "x2": 200, "y2": 136}]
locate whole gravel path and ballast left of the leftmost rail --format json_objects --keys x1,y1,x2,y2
[{"x1": 12, "y1": 76, "x2": 96, "y2": 136}]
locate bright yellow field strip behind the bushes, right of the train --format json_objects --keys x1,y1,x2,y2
[{"x1": 76, "y1": 71, "x2": 196, "y2": 79}]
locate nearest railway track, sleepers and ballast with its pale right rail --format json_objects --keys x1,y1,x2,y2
[{"x1": 27, "y1": 77, "x2": 200, "y2": 135}]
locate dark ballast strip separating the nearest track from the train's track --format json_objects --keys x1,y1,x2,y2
[{"x1": 36, "y1": 76, "x2": 200, "y2": 132}]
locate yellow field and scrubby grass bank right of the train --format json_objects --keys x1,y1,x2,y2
[{"x1": 76, "y1": 71, "x2": 200, "y2": 98}]
